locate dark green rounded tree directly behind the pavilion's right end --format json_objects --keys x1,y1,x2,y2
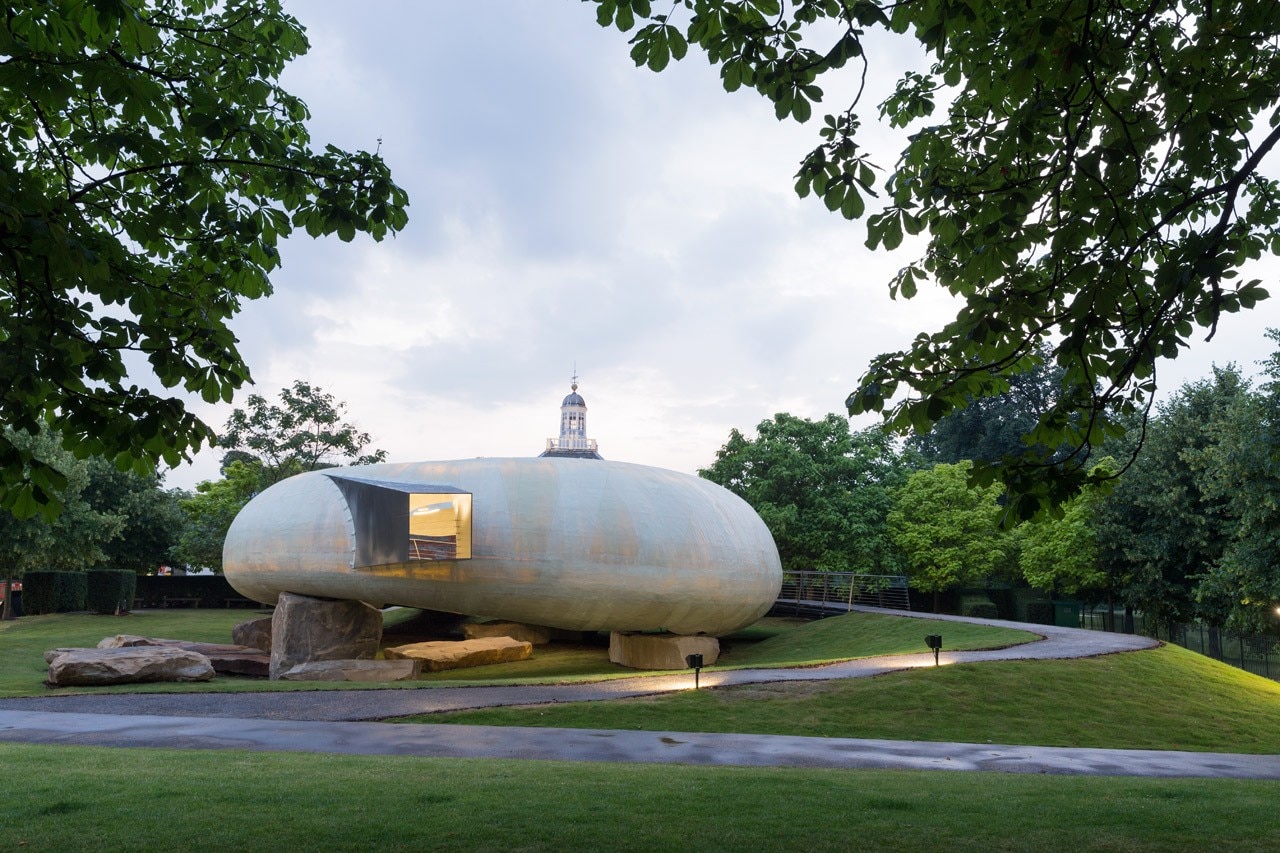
[{"x1": 698, "y1": 412, "x2": 906, "y2": 574}]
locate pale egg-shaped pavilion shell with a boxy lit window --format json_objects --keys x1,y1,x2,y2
[{"x1": 223, "y1": 459, "x2": 782, "y2": 635}]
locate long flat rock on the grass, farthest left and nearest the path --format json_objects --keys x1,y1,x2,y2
[{"x1": 47, "y1": 646, "x2": 214, "y2": 686}]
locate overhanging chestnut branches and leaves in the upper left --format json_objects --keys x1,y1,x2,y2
[{"x1": 0, "y1": 0, "x2": 408, "y2": 517}]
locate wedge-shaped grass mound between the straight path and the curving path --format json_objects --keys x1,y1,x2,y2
[{"x1": 406, "y1": 646, "x2": 1280, "y2": 753}]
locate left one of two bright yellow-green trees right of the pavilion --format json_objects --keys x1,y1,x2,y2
[{"x1": 888, "y1": 461, "x2": 1014, "y2": 611}]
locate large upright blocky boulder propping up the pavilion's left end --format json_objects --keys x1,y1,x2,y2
[{"x1": 271, "y1": 593, "x2": 383, "y2": 679}]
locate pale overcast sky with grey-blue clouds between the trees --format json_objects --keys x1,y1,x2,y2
[{"x1": 166, "y1": 0, "x2": 1280, "y2": 488}]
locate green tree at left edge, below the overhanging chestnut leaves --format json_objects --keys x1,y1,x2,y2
[{"x1": 0, "y1": 428, "x2": 124, "y2": 620}]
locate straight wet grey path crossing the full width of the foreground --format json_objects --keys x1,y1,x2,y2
[{"x1": 10, "y1": 711, "x2": 1280, "y2": 779}]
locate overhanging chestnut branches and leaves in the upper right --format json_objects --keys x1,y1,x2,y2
[{"x1": 593, "y1": 0, "x2": 1280, "y2": 517}]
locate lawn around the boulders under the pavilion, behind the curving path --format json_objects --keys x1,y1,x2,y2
[{"x1": 0, "y1": 608, "x2": 1036, "y2": 697}]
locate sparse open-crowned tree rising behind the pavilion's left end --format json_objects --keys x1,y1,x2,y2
[{"x1": 218, "y1": 380, "x2": 387, "y2": 488}]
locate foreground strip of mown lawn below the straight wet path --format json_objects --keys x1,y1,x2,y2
[{"x1": 0, "y1": 744, "x2": 1280, "y2": 853}]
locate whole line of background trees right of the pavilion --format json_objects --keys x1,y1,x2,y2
[{"x1": 699, "y1": 330, "x2": 1280, "y2": 633}]
